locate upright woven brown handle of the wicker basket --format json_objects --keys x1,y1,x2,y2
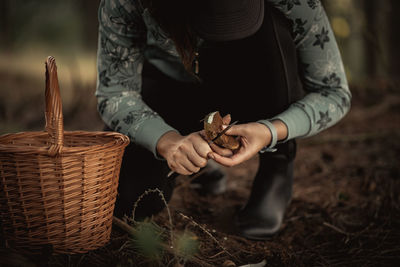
[{"x1": 45, "y1": 56, "x2": 64, "y2": 156}]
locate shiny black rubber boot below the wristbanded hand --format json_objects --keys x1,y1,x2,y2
[{"x1": 236, "y1": 142, "x2": 295, "y2": 240}]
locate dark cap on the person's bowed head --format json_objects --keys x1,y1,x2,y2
[{"x1": 190, "y1": 0, "x2": 265, "y2": 41}]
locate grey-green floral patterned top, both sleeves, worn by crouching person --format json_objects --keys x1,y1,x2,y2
[{"x1": 96, "y1": 0, "x2": 351, "y2": 155}]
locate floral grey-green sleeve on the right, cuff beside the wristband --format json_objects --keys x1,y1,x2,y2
[{"x1": 261, "y1": 0, "x2": 351, "y2": 140}]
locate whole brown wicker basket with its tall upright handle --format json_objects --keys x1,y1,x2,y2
[{"x1": 0, "y1": 57, "x2": 129, "y2": 254}]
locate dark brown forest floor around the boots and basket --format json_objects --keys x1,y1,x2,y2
[{"x1": 0, "y1": 85, "x2": 400, "y2": 266}]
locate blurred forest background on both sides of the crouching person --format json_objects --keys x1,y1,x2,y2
[{"x1": 0, "y1": 0, "x2": 400, "y2": 134}]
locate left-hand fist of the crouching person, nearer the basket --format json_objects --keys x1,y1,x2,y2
[{"x1": 157, "y1": 131, "x2": 212, "y2": 175}]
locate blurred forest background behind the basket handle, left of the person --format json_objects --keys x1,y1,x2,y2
[{"x1": 0, "y1": 0, "x2": 102, "y2": 134}]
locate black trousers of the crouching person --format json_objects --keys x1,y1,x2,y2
[{"x1": 115, "y1": 5, "x2": 302, "y2": 220}]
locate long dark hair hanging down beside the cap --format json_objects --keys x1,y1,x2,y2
[{"x1": 142, "y1": 0, "x2": 197, "y2": 74}]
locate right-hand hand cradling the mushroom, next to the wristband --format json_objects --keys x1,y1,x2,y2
[{"x1": 209, "y1": 122, "x2": 271, "y2": 167}]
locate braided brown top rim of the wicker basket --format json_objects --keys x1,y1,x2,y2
[{"x1": 0, "y1": 130, "x2": 130, "y2": 155}]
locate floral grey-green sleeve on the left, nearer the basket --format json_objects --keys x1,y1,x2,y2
[{"x1": 96, "y1": 0, "x2": 174, "y2": 158}]
